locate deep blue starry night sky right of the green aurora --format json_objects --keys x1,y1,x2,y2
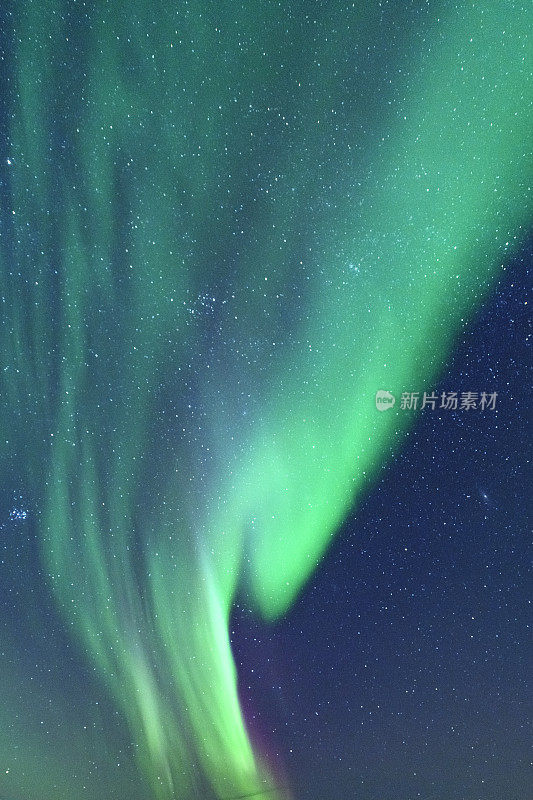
[{"x1": 234, "y1": 245, "x2": 533, "y2": 800}]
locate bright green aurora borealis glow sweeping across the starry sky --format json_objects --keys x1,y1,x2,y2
[{"x1": 0, "y1": 0, "x2": 532, "y2": 800}]
